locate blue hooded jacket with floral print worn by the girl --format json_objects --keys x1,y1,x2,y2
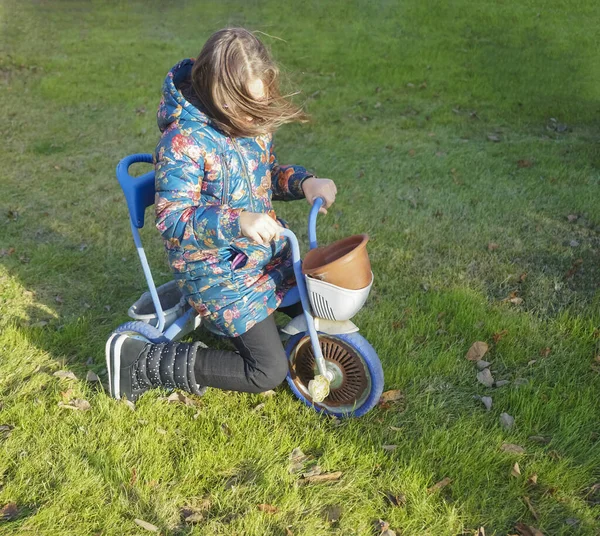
[{"x1": 155, "y1": 59, "x2": 311, "y2": 337}]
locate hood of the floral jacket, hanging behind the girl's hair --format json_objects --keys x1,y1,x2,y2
[{"x1": 156, "y1": 59, "x2": 211, "y2": 132}]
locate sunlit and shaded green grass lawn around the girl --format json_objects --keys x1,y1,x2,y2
[{"x1": 0, "y1": 0, "x2": 600, "y2": 536}]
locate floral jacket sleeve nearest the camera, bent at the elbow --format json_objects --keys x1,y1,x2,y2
[{"x1": 155, "y1": 133, "x2": 241, "y2": 250}]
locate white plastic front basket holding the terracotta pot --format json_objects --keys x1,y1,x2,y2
[{"x1": 304, "y1": 272, "x2": 374, "y2": 321}]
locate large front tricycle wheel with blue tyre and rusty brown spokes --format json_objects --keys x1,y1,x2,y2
[{"x1": 285, "y1": 333, "x2": 383, "y2": 417}]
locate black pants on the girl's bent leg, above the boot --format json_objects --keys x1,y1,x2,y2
[{"x1": 194, "y1": 304, "x2": 302, "y2": 393}]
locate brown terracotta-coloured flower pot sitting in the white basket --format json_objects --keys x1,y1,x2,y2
[{"x1": 302, "y1": 234, "x2": 372, "y2": 290}]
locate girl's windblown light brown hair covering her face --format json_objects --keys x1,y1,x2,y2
[{"x1": 192, "y1": 28, "x2": 308, "y2": 137}]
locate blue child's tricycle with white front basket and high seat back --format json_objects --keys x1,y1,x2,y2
[{"x1": 115, "y1": 154, "x2": 383, "y2": 417}]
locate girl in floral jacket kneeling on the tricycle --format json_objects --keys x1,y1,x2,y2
[{"x1": 106, "y1": 28, "x2": 337, "y2": 401}]
